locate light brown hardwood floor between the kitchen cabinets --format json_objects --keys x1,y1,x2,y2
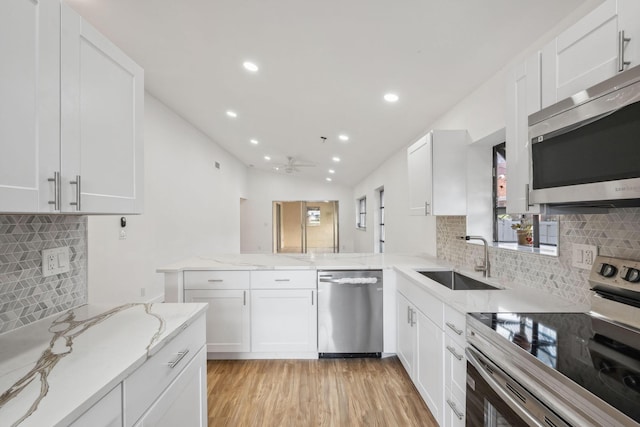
[{"x1": 207, "y1": 357, "x2": 438, "y2": 427}]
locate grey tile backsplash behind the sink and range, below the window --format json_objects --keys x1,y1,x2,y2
[{"x1": 436, "y1": 208, "x2": 640, "y2": 304}]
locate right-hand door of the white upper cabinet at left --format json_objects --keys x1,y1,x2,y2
[{"x1": 61, "y1": 3, "x2": 144, "y2": 213}]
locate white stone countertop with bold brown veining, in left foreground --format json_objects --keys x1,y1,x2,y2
[{"x1": 0, "y1": 303, "x2": 207, "y2": 427}]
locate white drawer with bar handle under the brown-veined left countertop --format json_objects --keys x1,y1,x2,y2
[{"x1": 124, "y1": 316, "x2": 205, "y2": 426}]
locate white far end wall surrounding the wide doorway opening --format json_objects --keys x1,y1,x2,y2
[{"x1": 240, "y1": 169, "x2": 358, "y2": 253}]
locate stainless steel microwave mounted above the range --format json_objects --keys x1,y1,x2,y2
[{"x1": 529, "y1": 66, "x2": 640, "y2": 207}]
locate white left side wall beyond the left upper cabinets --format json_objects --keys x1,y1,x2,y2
[{"x1": 88, "y1": 93, "x2": 249, "y2": 302}]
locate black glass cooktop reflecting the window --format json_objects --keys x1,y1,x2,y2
[{"x1": 470, "y1": 313, "x2": 640, "y2": 422}]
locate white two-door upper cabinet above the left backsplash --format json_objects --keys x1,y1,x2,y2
[{"x1": 0, "y1": 0, "x2": 144, "y2": 214}]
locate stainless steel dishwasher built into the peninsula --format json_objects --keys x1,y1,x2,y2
[{"x1": 318, "y1": 270, "x2": 383, "y2": 358}]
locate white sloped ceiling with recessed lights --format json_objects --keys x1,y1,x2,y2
[{"x1": 66, "y1": 0, "x2": 586, "y2": 185}]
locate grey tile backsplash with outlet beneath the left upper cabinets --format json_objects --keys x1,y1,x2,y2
[{"x1": 0, "y1": 215, "x2": 87, "y2": 333}]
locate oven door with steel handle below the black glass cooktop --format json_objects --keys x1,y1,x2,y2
[{"x1": 466, "y1": 348, "x2": 570, "y2": 427}]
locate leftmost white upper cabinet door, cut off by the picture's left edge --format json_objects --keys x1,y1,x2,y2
[{"x1": 0, "y1": 0, "x2": 60, "y2": 212}]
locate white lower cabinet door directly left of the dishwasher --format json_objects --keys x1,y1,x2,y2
[{"x1": 251, "y1": 289, "x2": 318, "y2": 352}]
